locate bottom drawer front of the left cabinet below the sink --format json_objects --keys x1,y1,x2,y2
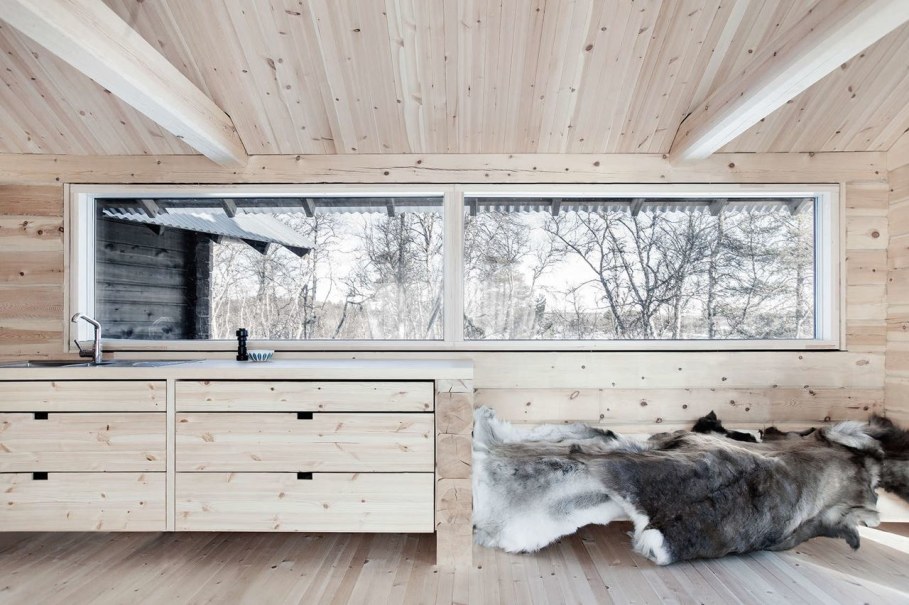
[{"x1": 0, "y1": 473, "x2": 165, "y2": 531}]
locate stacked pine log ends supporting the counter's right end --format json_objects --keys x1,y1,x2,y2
[{"x1": 435, "y1": 380, "x2": 473, "y2": 567}]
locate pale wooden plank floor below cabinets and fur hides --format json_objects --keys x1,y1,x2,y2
[{"x1": 0, "y1": 524, "x2": 909, "y2": 605}]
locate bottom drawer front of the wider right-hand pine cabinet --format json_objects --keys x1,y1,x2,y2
[{"x1": 176, "y1": 473, "x2": 435, "y2": 533}]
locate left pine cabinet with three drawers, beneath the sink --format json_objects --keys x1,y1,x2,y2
[{"x1": 0, "y1": 381, "x2": 167, "y2": 531}]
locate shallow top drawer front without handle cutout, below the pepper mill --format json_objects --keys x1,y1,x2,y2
[{"x1": 177, "y1": 380, "x2": 434, "y2": 412}]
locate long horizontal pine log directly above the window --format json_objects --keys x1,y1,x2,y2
[{"x1": 0, "y1": 153, "x2": 887, "y2": 186}]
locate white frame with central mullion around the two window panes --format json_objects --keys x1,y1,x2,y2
[{"x1": 64, "y1": 184, "x2": 845, "y2": 352}]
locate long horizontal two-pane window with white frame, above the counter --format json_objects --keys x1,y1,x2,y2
[{"x1": 68, "y1": 185, "x2": 840, "y2": 350}]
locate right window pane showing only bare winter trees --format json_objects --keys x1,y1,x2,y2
[{"x1": 464, "y1": 197, "x2": 815, "y2": 340}]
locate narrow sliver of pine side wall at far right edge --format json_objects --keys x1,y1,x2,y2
[{"x1": 886, "y1": 156, "x2": 909, "y2": 424}]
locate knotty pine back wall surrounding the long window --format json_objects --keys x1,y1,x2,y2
[{"x1": 0, "y1": 153, "x2": 892, "y2": 430}]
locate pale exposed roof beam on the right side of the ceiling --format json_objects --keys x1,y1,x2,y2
[{"x1": 669, "y1": 0, "x2": 909, "y2": 162}]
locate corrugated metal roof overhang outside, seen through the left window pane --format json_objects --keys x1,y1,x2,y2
[{"x1": 101, "y1": 208, "x2": 313, "y2": 255}]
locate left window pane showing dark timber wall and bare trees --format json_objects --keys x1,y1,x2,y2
[{"x1": 95, "y1": 197, "x2": 443, "y2": 340}]
